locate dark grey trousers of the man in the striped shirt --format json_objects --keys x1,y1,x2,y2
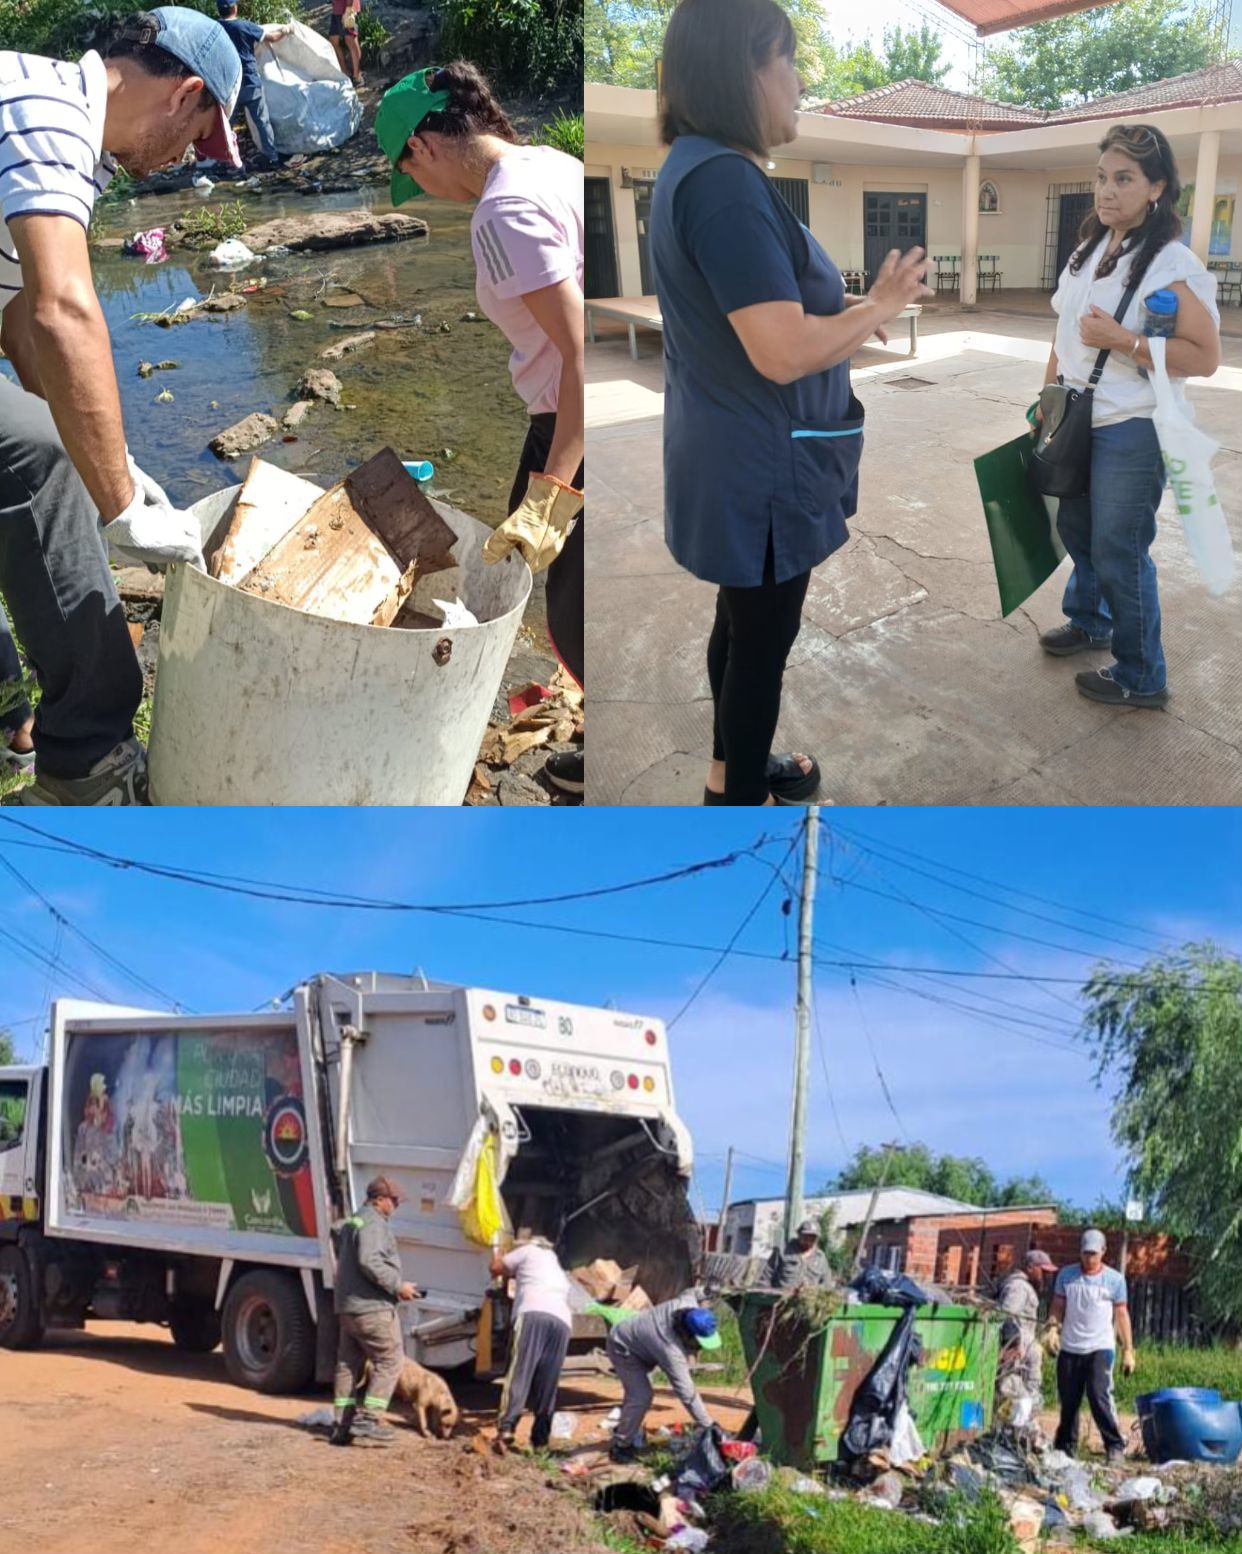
[{"x1": 0, "y1": 378, "x2": 143, "y2": 777}]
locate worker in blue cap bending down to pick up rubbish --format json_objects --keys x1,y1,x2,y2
[{"x1": 605, "y1": 1290, "x2": 720, "y2": 1462}]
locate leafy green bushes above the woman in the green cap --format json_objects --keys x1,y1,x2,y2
[{"x1": 438, "y1": 0, "x2": 583, "y2": 93}]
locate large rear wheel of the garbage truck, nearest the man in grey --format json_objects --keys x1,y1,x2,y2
[{"x1": 222, "y1": 1268, "x2": 316, "y2": 1392}]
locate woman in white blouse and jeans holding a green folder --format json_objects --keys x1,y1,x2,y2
[{"x1": 1040, "y1": 124, "x2": 1220, "y2": 707}]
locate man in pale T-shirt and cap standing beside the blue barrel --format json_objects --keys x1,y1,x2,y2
[{"x1": 1052, "y1": 1231, "x2": 1135, "y2": 1462}]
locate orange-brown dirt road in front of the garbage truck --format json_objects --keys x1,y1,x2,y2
[{"x1": 0, "y1": 1322, "x2": 745, "y2": 1554}]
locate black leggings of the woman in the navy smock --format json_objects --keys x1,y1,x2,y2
[{"x1": 707, "y1": 538, "x2": 811, "y2": 803}]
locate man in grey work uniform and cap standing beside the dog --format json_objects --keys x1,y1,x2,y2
[{"x1": 331, "y1": 1176, "x2": 418, "y2": 1445}]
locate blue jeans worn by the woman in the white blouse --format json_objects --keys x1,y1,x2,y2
[{"x1": 1057, "y1": 416, "x2": 1166, "y2": 693}]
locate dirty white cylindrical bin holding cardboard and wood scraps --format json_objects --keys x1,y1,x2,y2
[{"x1": 148, "y1": 486, "x2": 532, "y2": 805}]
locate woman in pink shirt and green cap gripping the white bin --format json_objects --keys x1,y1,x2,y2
[{"x1": 375, "y1": 59, "x2": 586, "y2": 793}]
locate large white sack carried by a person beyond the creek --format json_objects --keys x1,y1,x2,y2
[{"x1": 255, "y1": 22, "x2": 362, "y2": 157}]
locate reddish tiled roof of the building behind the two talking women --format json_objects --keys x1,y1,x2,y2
[{"x1": 807, "y1": 59, "x2": 1242, "y2": 129}]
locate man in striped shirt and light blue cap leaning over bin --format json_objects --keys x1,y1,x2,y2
[{"x1": 0, "y1": 6, "x2": 241, "y2": 805}]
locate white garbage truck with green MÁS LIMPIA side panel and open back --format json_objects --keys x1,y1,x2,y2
[{"x1": 0, "y1": 971, "x2": 698, "y2": 1392}]
